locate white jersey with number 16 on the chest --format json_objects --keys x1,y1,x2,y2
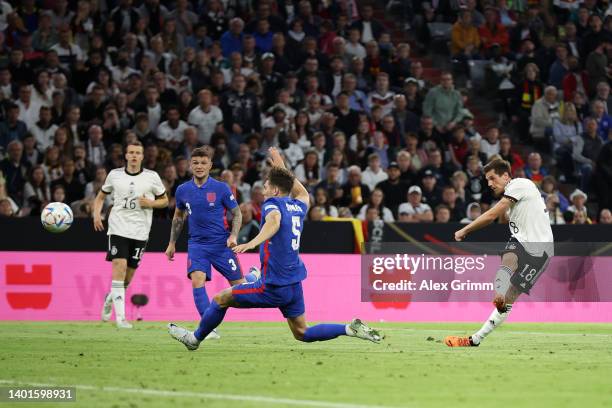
[{"x1": 102, "y1": 168, "x2": 166, "y2": 241}]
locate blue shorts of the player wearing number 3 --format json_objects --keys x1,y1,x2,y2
[{"x1": 187, "y1": 244, "x2": 242, "y2": 281}]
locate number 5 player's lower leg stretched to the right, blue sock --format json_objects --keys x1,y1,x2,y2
[{"x1": 287, "y1": 315, "x2": 384, "y2": 343}]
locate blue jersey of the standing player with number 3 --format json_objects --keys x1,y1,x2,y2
[{"x1": 175, "y1": 177, "x2": 238, "y2": 247}]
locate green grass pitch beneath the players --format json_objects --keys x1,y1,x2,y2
[{"x1": 0, "y1": 322, "x2": 612, "y2": 408}]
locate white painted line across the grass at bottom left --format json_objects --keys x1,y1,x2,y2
[{"x1": 0, "y1": 380, "x2": 404, "y2": 408}]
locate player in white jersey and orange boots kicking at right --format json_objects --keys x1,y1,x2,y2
[{"x1": 444, "y1": 159, "x2": 554, "y2": 347}]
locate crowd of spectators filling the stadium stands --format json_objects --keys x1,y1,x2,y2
[{"x1": 0, "y1": 0, "x2": 612, "y2": 235}]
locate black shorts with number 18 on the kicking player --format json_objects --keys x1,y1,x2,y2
[{"x1": 501, "y1": 237, "x2": 550, "y2": 294}]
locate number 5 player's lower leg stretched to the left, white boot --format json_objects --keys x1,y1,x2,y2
[{"x1": 168, "y1": 288, "x2": 232, "y2": 350}]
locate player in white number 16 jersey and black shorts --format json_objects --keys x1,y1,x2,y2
[{"x1": 93, "y1": 142, "x2": 168, "y2": 329}]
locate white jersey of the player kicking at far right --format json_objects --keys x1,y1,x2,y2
[{"x1": 504, "y1": 178, "x2": 554, "y2": 256}]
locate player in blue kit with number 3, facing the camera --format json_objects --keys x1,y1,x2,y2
[{"x1": 166, "y1": 146, "x2": 259, "y2": 339}]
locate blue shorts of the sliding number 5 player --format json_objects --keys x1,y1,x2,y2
[{"x1": 232, "y1": 279, "x2": 305, "y2": 318}]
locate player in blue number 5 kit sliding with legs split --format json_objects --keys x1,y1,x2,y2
[{"x1": 168, "y1": 148, "x2": 383, "y2": 350}]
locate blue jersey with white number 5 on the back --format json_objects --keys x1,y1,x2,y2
[{"x1": 259, "y1": 196, "x2": 308, "y2": 286}]
